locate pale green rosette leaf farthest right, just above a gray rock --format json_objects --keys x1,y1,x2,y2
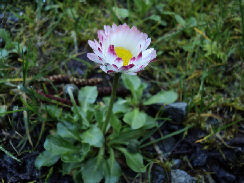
[{"x1": 144, "y1": 91, "x2": 178, "y2": 105}]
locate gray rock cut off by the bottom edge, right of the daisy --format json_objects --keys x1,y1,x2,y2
[{"x1": 171, "y1": 169, "x2": 196, "y2": 183}]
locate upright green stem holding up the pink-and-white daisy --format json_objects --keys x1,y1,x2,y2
[{"x1": 103, "y1": 73, "x2": 121, "y2": 134}]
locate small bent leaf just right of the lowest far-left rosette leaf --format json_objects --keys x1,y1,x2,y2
[{"x1": 61, "y1": 144, "x2": 90, "y2": 163}]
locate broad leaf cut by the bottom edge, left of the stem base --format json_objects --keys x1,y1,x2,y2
[{"x1": 81, "y1": 158, "x2": 103, "y2": 183}]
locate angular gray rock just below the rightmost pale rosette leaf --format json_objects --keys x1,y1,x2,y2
[{"x1": 164, "y1": 102, "x2": 187, "y2": 123}]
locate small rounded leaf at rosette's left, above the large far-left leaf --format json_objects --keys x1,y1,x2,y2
[{"x1": 57, "y1": 122, "x2": 79, "y2": 140}]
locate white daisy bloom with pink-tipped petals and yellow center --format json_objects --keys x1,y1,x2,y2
[{"x1": 87, "y1": 24, "x2": 156, "y2": 75}]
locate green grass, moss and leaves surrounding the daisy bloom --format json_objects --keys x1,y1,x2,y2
[{"x1": 0, "y1": 0, "x2": 244, "y2": 183}]
